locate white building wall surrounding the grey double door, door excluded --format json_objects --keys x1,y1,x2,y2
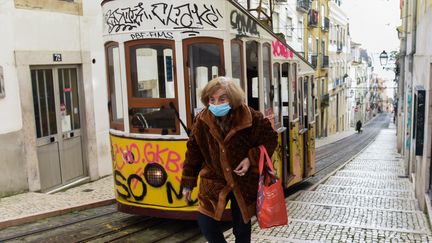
[{"x1": 0, "y1": 1, "x2": 112, "y2": 197}]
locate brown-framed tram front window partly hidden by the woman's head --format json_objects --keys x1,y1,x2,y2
[{"x1": 183, "y1": 38, "x2": 225, "y2": 127}]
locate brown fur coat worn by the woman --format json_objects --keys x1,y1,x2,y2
[{"x1": 181, "y1": 105, "x2": 277, "y2": 223}]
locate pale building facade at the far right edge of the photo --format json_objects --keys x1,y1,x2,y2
[{"x1": 397, "y1": 0, "x2": 432, "y2": 212}]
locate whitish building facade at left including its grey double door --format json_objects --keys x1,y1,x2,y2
[{"x1": 0, "y1": 0, "x2": 111, "y2": 197}]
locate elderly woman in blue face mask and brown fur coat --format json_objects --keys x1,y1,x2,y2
[{"x1": 181, "y1": 77, "x2": 277, "y2": 242}]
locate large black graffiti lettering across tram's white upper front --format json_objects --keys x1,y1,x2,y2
[{"x1": 105, "y1": 2, "x2": 223, "y2": 35}]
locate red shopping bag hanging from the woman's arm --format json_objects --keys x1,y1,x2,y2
[{"x1": 257, "y1": 145, "x2": 288, "y2": 229}]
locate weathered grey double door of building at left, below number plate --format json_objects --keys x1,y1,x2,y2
[{"x1": 31, "y1": 67, "x2": 85, "y2": 191}]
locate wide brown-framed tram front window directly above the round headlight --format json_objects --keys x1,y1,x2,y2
[{"x1": 125, "y1": 40, "x2": 179, "y2": 135}]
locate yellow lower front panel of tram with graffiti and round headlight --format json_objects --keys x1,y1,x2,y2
[{"x1": 111, "y1": 136, "x2": 197, "y2": 207}]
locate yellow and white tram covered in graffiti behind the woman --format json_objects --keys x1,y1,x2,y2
[{"x1": 102, "y1": 0, "x2": 315, "y2": 219}]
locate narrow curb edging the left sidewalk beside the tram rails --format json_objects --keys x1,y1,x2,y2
[{"x1": 0, "y1": 198, "x2": 115, "y2": 229}]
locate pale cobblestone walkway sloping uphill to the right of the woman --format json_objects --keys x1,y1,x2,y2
[{"x1": 225, "y1": 125, "x2": 432, "y2": 243}]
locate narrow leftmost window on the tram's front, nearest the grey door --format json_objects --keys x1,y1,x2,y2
[{"x1": 106, "y1": 43, "x2": 124, "y2": 130}]
